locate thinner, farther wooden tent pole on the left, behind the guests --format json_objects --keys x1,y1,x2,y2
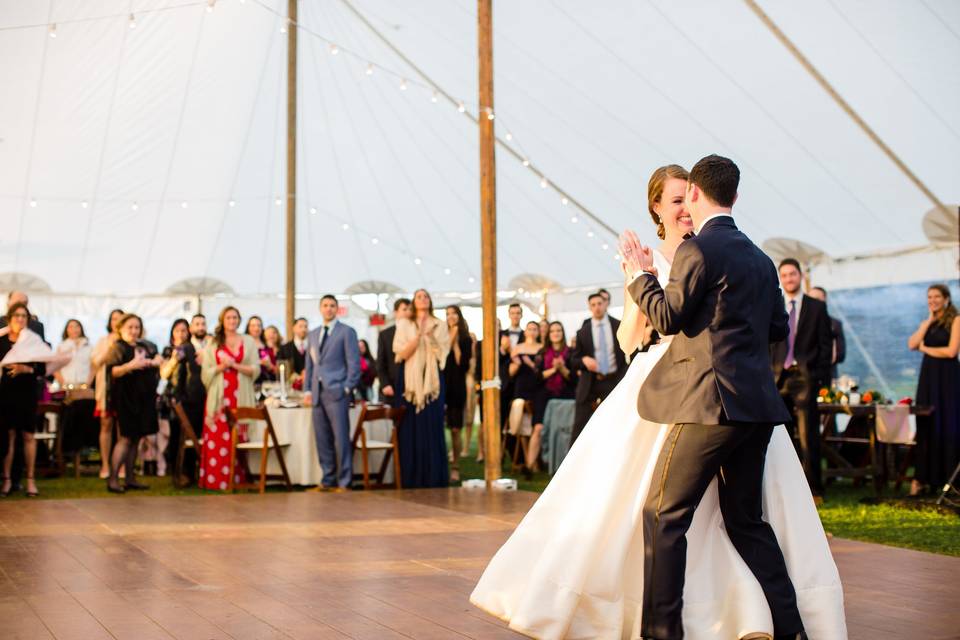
[{"x1": 285, "y1": 0, "x2": 297, "y2": 336}]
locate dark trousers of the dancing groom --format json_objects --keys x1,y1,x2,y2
[{"x1": 642, "y1": 423, "x2": 803, "y2": 640}]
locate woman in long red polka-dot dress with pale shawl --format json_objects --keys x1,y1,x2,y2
[{"x1": 198, "y1": 307, "x2": 260, "y2": 491}]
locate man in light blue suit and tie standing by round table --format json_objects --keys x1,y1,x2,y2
[{"x1": 304, "y1": 295, "x2": 360, "y2": 491}]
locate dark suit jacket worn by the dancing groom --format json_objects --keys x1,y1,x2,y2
[{"x1": 628, "y1": 216, "x2": 790, "y2": 425}]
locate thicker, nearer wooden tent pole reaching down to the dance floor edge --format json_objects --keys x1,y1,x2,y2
[{"x1": 477, "y1": 0, "x2": 501, "y2": 490}]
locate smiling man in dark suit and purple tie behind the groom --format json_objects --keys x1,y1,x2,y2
[{"x1": 770, "y1": 258, "x2": 833, "y2": 498}]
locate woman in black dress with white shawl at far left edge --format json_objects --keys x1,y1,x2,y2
[{"x1": 0, "y1": 302, "x2": 44, "y2": 498}]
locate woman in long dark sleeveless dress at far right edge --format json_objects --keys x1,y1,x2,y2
[{"x1": 908, "y1": 284, "x2": 960, "y2": 495}]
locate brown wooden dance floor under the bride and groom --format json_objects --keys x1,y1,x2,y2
[{"x1": 0, "y1": 489, "x2": 960, "y2": 640}]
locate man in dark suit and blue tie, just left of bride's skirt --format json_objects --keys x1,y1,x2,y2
[{"x1": 570, "y1": 292, "x2": 627, "y2": 446}]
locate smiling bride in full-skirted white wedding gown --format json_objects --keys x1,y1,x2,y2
[{"x1": 470, "y1": 165, "x2": 847, "y2": 640}]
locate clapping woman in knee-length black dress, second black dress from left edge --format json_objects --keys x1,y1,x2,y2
[{"x1": 107, "y1": 313, "x2": 163, "y2": 493}]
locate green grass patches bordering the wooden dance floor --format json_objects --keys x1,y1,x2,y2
[{"x1": 6, "y1": 429, "x2": 960, "y2": 556}]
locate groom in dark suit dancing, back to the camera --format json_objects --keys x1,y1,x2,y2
[{"x1": 620, "y1": 155, "x2": 805, "y2": 640}]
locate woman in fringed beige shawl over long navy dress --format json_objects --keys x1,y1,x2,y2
[{"x1": 393, "y1": 289, "x2": 450, "y2": 488}]
